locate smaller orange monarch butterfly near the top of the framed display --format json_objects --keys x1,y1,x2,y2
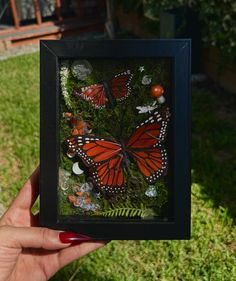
[{"x1": 74, "y1": 70, "x2": 133, "y2": 109}]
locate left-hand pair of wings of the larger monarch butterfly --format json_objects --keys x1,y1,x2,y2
[{"x1": 67, "y1": 135, "x2": 126, "y2": 193}]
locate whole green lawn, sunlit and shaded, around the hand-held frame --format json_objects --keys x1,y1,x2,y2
[{"x1": 0, "y1": 53, "x2": 236, "y2": 281}]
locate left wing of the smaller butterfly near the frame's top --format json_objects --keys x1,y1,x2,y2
[{"x1": 74, "y1": 84, "x2": 108, "y2": 109}]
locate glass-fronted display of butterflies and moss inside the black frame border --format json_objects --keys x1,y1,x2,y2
[{"x1": 58, "y1": 58, "x2": 172, "y2": 220}]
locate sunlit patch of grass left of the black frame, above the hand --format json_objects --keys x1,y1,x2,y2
[{"x1": 0, "y1": 53, "x2": 39, "y2": 201}]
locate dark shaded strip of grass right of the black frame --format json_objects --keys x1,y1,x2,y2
[{"x1": 192, "y1": 83, "x2": 236, "y2": 223}]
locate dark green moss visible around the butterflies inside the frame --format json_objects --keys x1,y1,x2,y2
[{"x1": 60, "y1": 59, "x2": 171, "y2": 217}]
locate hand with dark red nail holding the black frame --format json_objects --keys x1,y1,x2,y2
[{"x1": 0, "y1": 169, "x2": 105, "y2": 281}]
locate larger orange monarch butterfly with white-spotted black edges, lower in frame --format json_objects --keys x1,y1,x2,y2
[{"x1": 67, "y1": 108, "x2": 169, "y2": 193}]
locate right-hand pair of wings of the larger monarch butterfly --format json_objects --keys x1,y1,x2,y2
[{"x1": 126, "y1": 109, "x2": 169, "y2": 184}]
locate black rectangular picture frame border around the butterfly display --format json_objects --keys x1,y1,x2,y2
[{"x1": 40, "y1": 39, "x2": 191, "y2": 240}]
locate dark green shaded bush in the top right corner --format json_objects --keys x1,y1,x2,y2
[{"x1": 121, "y1": 0, "x2": 236, "y2": 58}]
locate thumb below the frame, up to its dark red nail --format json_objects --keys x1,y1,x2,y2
[{"x1": 0, "y1": 226, "x2": 71, "y2": 250}]
